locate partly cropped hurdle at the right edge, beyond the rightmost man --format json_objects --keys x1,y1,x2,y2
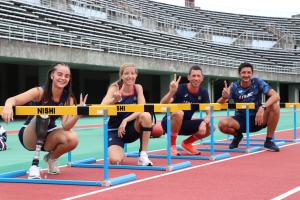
[{"x1": 250, "y1": 103, "x2": 300, "y2": 144}]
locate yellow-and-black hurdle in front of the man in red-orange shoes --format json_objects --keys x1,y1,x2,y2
[{"x1": 127, "y1": 103, "x2": 230, "y2": 160}]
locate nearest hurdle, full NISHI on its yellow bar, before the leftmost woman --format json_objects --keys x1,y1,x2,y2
[{"x1": 0, "y1": 105, "x2": 136, "y2": 187}]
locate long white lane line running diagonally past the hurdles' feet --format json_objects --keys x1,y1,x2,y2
[{"x1": 63, "y1": 143, "x2": 299, "y2": 200}]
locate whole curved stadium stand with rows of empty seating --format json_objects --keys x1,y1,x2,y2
[{"x1": 0, "y1": 0, "x2": 300, "y2": 74}]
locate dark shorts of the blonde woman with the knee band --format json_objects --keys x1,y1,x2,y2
[{"x1": 108, "y1": 120, "x2": 140, "y2": 148}]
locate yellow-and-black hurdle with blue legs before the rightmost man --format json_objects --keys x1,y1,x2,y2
[{"x1": 199, "y1": 103, "x2": 276, "y2": 153}]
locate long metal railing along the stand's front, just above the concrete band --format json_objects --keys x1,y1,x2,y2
[{"x1": 0, "y1": 23, "x2": 300, "y2": 74}]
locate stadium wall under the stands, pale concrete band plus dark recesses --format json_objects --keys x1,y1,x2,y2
[{"x1": 0, "y1": 39, "x2": 300, "y2": 103}]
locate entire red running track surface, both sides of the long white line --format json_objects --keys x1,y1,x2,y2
[{"x1": 0, "y1": 129, "x2": 300, "y2": 200}]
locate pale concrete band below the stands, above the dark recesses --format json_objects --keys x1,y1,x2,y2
[{"x1": 0, "y1": 39, "x2": 300, "y2": 83}]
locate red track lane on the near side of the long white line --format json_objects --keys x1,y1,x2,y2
[{"x1": 63, "y1": 144, "x2": 300, "y2": 200}]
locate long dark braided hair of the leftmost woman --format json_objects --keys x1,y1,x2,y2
[{"x1": 42, "y1": 63, "x2": 76, "y2": 105}]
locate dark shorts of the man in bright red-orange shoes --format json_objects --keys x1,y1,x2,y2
[{"x1": 161, "y1": 117, "x2": 203, "y2": 135}]
